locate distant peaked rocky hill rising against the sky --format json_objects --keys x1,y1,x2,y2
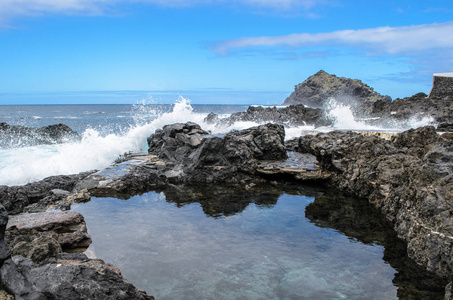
[{"x1": 283, "y1": 70, "x2": 391, "y2": 108}]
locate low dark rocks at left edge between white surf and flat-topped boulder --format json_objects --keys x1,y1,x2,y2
[{"x1": 0, "y1": 172, "x2": 92, "y2": 215}]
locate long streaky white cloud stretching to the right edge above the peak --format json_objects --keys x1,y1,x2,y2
[{"x1": 212, "y1": 22, "x2": 453, "y2": 55}]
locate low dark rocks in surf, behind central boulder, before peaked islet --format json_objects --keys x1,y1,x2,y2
[{"x1": 205, "y1": 104, "x2": 331, "y2": 127}]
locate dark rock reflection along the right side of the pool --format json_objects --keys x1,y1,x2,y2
[{"x1": 305, "y1": 195, "x2": 446, "y2": 299}]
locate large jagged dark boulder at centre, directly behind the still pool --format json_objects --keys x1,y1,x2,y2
[{"x1": 148, "y1": 123, "x2": 287, "y2": 183}]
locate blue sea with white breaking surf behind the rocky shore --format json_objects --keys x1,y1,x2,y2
[{"x1": 0, "y1": 97, "x2": 430, "y2": 185}]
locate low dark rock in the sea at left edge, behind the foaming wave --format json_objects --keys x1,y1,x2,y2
[{"x1": 0, "y1": 123, "x2": 81, "y2": 148}]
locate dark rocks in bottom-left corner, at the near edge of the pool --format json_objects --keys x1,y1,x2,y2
[{"x1": 0, "y1": 205, "x2": 154, "y2": 300}]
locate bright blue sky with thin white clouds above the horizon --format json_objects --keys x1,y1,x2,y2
[{"x1": 0, "y1": 0, "x2": 453, "y2": 104}]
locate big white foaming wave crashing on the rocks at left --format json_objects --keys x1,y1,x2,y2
[{"x1": 0, "y1": 98, "x2": 203, "y2": 185}]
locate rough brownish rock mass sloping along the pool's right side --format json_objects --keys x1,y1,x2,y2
[{"x1": 299, "y1": 127, "x2": 453, "y2": 278}]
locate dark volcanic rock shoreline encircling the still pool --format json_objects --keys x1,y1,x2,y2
[{"x1": 0, "y1": 74, "x2": 453, "y2": 299}]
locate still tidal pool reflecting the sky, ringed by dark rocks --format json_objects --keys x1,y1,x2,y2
[{"x1": 72, "y1": 186, "x2": 445, "y2": 300}]
